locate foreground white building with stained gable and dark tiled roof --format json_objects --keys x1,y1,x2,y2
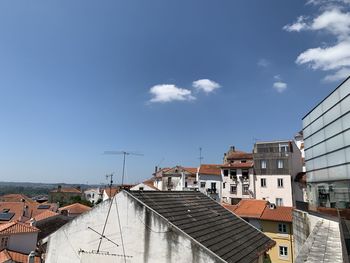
[{"x1": 46, "y1": 190, "x2": 275, "y2": 263}]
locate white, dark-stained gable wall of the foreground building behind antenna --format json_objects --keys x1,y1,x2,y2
[{"x1": 46, "y1": 192, "x2": 222, "y2": 263}]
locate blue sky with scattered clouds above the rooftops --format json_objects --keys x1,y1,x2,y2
[{"x1": 0, "y1": 0, "x2": 350, "y2": 186}]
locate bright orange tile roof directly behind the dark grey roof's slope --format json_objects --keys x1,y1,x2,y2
[{"x1": 223, "y1": 199, "x2": 268, "y2": 219}]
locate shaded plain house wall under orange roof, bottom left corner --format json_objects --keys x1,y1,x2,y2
[{"x1": 7, "y1": 233, "x2": 38, "y2": 254}]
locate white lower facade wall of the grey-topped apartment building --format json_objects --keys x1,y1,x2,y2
[{"x1": 255, "y1": 175, "x2": 293, "y2": 206}]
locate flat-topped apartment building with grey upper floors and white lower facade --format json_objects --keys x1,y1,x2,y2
[{"x1": 253, "y1": 140, "x2": 302, "y2": 206}]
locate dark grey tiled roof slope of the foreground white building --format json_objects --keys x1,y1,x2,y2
[{"x1": 129, "y1": 191, "x2": 275, "y2": 262}]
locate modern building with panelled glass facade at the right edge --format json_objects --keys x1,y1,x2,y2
[{"x1": 303, "y1": 77, "x2": 350, "y2": 208}]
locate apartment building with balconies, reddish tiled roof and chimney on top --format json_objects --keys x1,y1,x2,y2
[{"x1": 221, "y1": 146, "x2": 255, "y2": 204}]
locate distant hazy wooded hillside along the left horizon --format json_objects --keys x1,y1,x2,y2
[{"x1": 0, "y1": 182, "x2": 102, "y2": 197}]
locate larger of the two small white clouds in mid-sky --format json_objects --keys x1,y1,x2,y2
[{"x1": 149, "y1": 84, "x2": 196, "y2": 103}]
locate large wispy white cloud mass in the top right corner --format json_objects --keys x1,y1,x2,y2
[{"x1": 283, "y1": 5, "x2": 350, "y2": 81}]
